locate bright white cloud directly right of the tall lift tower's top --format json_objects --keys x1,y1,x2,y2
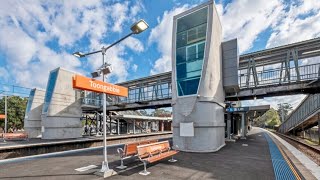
[{"x1": 217, "y1": 0, "x2": 284, "y2": 53}]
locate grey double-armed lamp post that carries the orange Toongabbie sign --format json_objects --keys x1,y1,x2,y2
[{"x1": 73, "y1": 19, "x2": 149, "y2": 177}]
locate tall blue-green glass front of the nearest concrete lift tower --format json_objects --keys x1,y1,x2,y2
[{"x1": 176, "y1": 8, "x2": 208, "y2": 96}]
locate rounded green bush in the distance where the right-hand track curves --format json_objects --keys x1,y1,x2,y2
[{"x1": 255, "y1": 108, "x2": 281, "y2": 126}]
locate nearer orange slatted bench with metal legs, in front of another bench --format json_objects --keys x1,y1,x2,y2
[{"x1": 137, "y1": 141, "x2": 179, "y2": 175}]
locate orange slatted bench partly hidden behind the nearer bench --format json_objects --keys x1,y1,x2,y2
[{"x1": 117, "y1": 139, "x2": 158, "y2": 169}]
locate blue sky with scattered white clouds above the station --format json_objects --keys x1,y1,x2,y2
[{"x1": 0, "y1": 0, "x2": 320, "y2": 110}]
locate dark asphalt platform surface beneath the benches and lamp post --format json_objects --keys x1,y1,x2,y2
[{"x1": 0, "y1": 129, "x2": 275, "y2": 180}]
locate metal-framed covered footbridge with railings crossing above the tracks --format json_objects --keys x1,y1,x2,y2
[{"x1": 83, "y1": 38, "x2": 320, "y2": 110}]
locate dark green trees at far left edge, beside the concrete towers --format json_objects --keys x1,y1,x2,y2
[{"x1": 0, "y1": 96, "x2": 28, "y2": 129}]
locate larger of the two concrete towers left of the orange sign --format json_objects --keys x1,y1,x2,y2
[{"x1": 41, "y1": 68, "x2": 83, "y2": 139}]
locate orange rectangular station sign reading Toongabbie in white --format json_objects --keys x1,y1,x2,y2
[{"x1": 73, "y1": 75, "x2": 128, "y2": 97}]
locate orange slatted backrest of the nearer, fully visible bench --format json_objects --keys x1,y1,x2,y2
[{"x1": 137, "y1": 141, "x2": 170, "y2": 158}]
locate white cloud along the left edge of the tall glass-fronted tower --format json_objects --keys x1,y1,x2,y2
[{"x1": 149, "y1": 5, "x2": 189, "y2": 74}]
